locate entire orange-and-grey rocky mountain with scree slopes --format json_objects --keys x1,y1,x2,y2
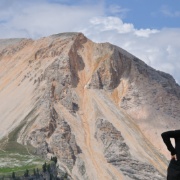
[{"x1": 0, "y1": 33, "x2": 180, "y2": 180}]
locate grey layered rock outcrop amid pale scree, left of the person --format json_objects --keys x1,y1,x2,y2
[{"x1": 95, "y1": 119, "x2": 165, "y2": 180}]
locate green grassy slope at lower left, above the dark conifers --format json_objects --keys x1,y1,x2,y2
[{"x1": 0, "y1": 109, "x2": 44, "y2": 175}]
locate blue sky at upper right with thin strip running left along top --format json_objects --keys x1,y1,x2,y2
[{"x1": 44, "y1": 0, "x2": 180, "y2": 29}]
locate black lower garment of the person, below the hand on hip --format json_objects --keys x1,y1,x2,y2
[{"x1": 167, "y1": 159, "x2": 180, "y2": 180}]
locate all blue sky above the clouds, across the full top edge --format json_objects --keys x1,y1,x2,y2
[{"x1": 0, "y1": 0, "x2": 180, "y2": 29}]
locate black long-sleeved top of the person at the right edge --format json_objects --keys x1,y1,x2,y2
[{"x1": 161, "y1": 130, "x2": 180, "y2": 160}]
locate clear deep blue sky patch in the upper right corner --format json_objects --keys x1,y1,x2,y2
[{"x1": 106, "y1": 0, "x2": 180, "y2": 28}]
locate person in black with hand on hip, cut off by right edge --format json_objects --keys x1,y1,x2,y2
[{"x1": 161, "y1": 130, "x2": 180, "y2": 180}]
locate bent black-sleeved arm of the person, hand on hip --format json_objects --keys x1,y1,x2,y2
[{"x1": 161, "y1": 130, "x2": 180, "y2": 156}]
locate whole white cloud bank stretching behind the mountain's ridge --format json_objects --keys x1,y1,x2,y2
[{"x1": 0, "y1": 0, "x2": 180, "y2": 83}]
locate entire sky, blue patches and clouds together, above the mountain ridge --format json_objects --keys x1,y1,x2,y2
[{"x1": 0, "y1": 0, "x2": 180, "y2": 84}]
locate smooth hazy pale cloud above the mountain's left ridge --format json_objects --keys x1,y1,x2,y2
[{"x1": 0, "y1": 1, "x2": 103, "y2": 38}]
